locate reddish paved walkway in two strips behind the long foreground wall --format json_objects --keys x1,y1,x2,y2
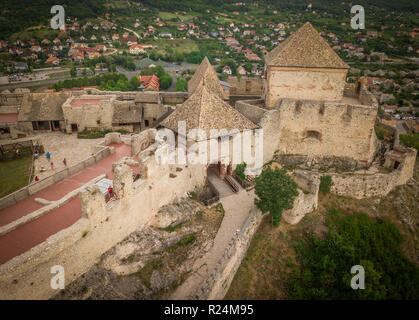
[{"x1": 0, "y1": 144, "x2": 131, "y2": 264}]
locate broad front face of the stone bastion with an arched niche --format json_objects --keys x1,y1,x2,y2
[{"x1": 278, "y1": 99, "x2": 377, "y2": 166}]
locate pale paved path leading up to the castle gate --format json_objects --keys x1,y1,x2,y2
[{"x1": 170, "y1": 189, "x2": 255, "y2": 300}]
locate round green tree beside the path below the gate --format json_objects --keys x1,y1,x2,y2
[{"x1": 255, "y1": 168, "x2": 298, "y2": 226}]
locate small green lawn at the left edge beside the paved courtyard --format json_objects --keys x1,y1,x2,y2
[{"x1": 0, "y1": 155, "x2": 32, "y2": 198}]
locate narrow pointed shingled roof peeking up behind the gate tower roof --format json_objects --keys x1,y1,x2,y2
[{"x1": 188, "y1": 57, "x2": 225, "y2": 99}]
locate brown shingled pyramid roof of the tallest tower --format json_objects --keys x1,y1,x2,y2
[{"x1": 265, "y1": 22, "x2": 349, "y2": 69}]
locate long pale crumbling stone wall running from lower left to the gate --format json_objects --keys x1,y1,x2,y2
[{"x1": 0, "y1": 138, "x2": 206, "y2": 299}]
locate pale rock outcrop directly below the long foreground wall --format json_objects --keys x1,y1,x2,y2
[{"x1": 151, "y1": 199, "x2": 198, "y2": 228}]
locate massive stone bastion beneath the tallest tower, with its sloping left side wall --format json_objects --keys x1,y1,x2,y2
[{"x1": 235, "y1": 86, "x2": 378, "y2": 167}]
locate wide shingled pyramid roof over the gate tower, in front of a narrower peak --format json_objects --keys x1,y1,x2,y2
[{"x1": 161, "y1": 85, "x2": 258, "y2": 138}]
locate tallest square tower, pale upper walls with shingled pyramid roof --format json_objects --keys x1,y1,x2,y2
[{"x1": 263, "y1": 22, "x2": 349, "y2": 108}]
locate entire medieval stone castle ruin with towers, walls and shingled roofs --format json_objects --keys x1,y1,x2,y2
[{"x1": 0, "y1": 23, "x2": 416, "y2": 299}]
